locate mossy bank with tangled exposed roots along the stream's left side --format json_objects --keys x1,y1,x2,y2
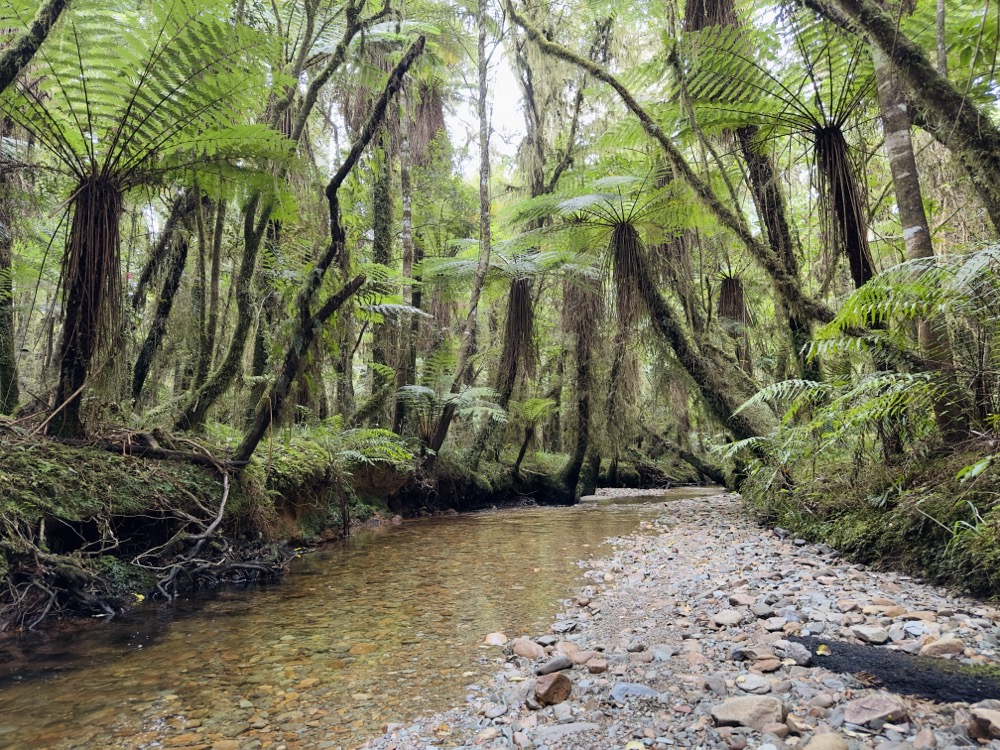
[{"x1": 0, "y1": 426, "x2": 697, "y2": 630}]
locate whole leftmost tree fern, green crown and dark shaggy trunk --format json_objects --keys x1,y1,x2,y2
[{"x1": 0, "y1": 0, "x2": 290, "y2": 435}]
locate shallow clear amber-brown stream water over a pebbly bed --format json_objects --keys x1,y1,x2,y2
[{"x1": 0, "y1": 489, "x2": 710, "y2": 750}]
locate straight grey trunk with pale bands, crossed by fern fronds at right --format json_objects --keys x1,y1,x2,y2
[{"x1": 872, "y1": 47, "x2": 968, "y2": 441}]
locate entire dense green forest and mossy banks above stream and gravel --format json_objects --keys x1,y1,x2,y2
[{"x1": 0, "y1": 0, "x2": 1000, "y2": 626}]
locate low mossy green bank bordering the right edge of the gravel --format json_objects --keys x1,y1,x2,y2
[{"x1": 743, "y1": 441, "x2": 1000, "y2": 597}]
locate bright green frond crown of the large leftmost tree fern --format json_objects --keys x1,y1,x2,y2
[{"x1": 4, "y1": 0, "x2": 288, "y2": 189}]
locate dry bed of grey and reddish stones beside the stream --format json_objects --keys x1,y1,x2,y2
[{"x1": 364, "y1": 494, "x2": 1000, "y2": 750}]
